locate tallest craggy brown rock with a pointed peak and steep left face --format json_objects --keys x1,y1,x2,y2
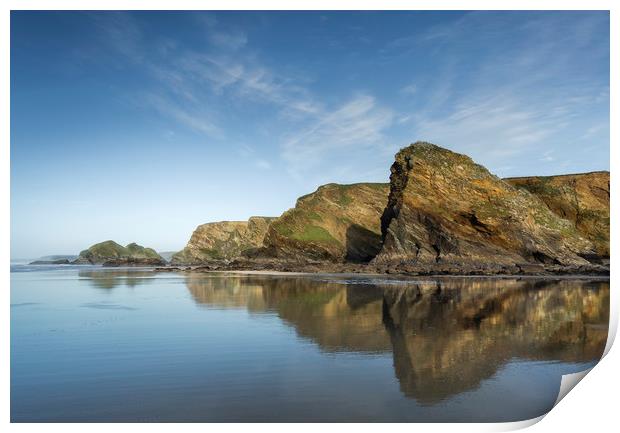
[{"x1": 376, "y1": 142, "x2": 594, "y2": 272}]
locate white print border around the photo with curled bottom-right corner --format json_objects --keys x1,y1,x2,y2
[{"x1": 0, "y1": 0, "x2": 620, "y2": 433}]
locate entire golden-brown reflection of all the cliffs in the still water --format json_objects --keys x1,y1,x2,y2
[{"x1": 186, "y1": 274, "x2": 609, "y2": 403}]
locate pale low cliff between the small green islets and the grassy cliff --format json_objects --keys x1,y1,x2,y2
[{"x1": 172, "y1": 217, "x2": 275, "y2": 264}]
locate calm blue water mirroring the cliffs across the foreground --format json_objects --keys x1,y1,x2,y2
[{"x1": 11, "y1": 266, "x2": 609, "y2": 422}]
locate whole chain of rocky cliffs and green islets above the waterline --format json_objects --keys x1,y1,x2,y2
[{"x1": 65, "y1": 142, "x2": 609, "y2": 275}]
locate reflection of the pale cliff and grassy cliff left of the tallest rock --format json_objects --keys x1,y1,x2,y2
[{"x1": 186, "y1": 274, "x2": 392, "y2": 352}]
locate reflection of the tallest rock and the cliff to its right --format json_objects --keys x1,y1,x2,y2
[{"x1": 384, "y1": 280, "x2": 609, "y2": 403}]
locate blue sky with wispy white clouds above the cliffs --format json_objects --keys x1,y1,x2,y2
[{"x1": 11, "y1": 11, "x2": 610, "y2": 258}]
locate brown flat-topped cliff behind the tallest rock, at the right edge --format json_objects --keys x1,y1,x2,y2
[{"x1": 504, "y1": 171, "x2": 609, "y2": 259}]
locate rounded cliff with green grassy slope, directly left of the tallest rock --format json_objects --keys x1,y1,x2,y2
[{"x1": 264, "y1": 183, "x2": 389, "y2": 262}]
